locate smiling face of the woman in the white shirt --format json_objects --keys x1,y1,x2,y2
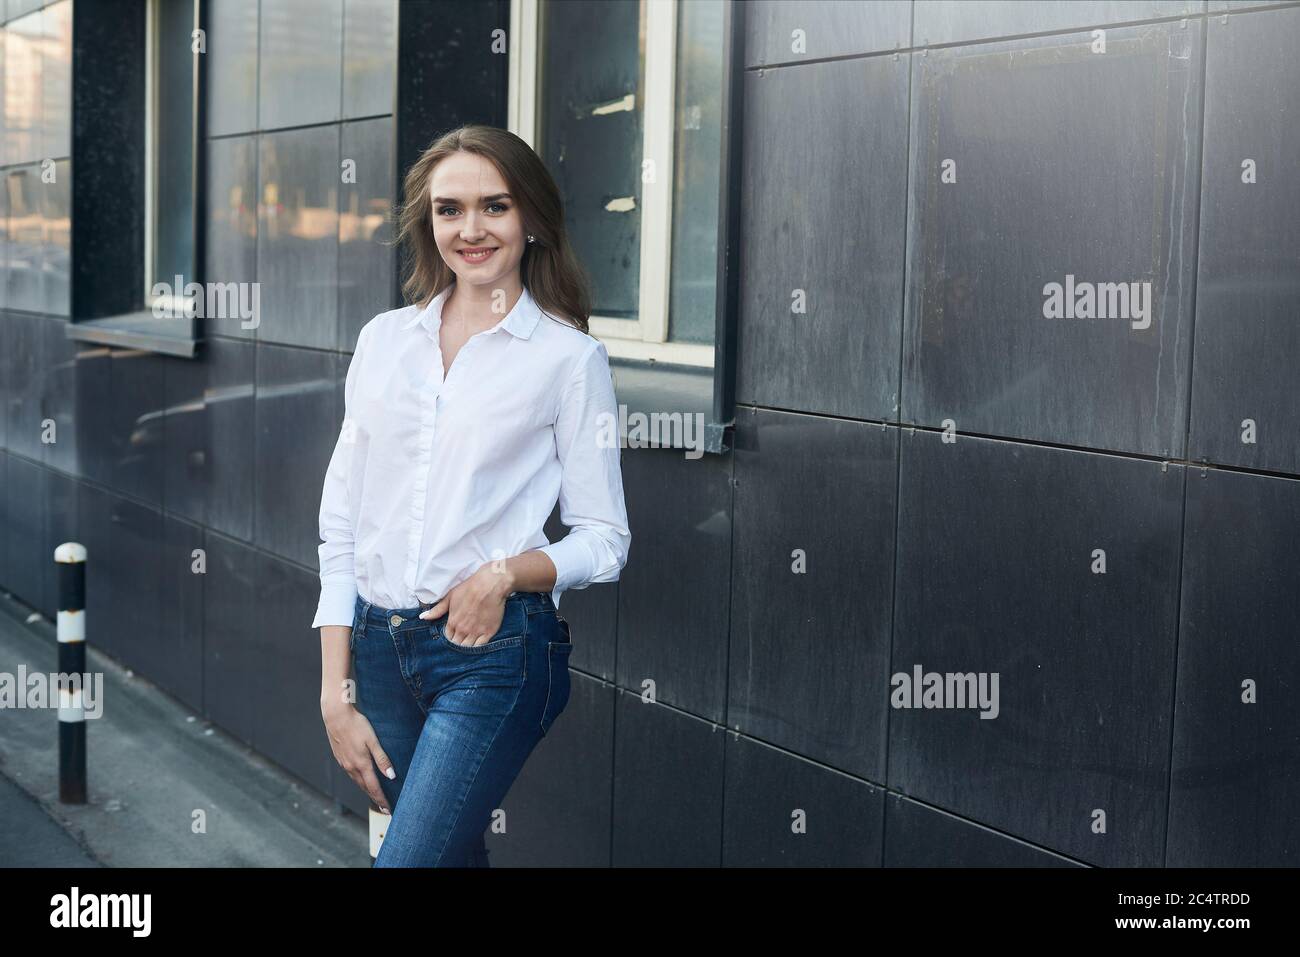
[{"x1": 429, "y1": 152, "x2": 527, "y2": 289}]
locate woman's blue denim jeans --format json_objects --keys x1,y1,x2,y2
[{"x1": 351, "y1": 592, "x2": 573, "y2": 867}]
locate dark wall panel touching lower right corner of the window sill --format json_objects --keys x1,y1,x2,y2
[{"x1": 727, "y1": 410, "x2": 898, "y2": 781}]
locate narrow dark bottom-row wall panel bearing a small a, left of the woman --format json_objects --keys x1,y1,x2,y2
[{"x1": 158, "y1": 512, "x2": 204, "y2": 713}]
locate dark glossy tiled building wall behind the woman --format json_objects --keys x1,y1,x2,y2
[{"x1": 0, "y1": 0, "x2": 1300, "y2": 866}]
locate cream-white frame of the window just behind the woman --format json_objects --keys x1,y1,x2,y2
[{"x1": 507, "y1": 0, "x2": 714, "y2": 368}]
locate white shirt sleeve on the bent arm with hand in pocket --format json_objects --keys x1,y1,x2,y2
[{"x1": 541, "y1": 339, "x2": 632, "y2": 596}]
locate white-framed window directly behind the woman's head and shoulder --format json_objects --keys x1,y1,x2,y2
[{"x1": 510, "y1": 0, "x2": 725, "y2": 369}]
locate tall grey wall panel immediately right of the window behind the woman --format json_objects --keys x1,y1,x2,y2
[{"x1": 736, "y1": 56, "x2": 907, "y2": 419}]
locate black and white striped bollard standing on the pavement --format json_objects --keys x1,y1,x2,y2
[{"x1": 55, "y1": 542, "x2": 86, "y2": 804}]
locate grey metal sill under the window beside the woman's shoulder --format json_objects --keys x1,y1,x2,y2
[{"x1": 610, "y1": 355, "x2": 731, "y2": 458}]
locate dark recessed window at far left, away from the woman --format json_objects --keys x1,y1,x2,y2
[{"x1": 68, "y1": 0, "x2": 204, "y2": 358}]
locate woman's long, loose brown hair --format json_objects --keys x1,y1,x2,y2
[{"x1": 395, "y1": 124, "x2": 592, "y2": 333}]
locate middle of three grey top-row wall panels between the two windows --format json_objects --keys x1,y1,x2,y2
[{"x1": 254, "y1": 0, "x2": 343, "y2": 130}]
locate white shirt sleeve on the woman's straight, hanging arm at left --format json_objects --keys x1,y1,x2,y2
[{"x1": 304, "y1": 328, "x2": 367, "y2": 628}]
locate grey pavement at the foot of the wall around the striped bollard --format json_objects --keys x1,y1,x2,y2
[{"x1": 0, "y1": 592, "x2": 371, "y2": 867}]
